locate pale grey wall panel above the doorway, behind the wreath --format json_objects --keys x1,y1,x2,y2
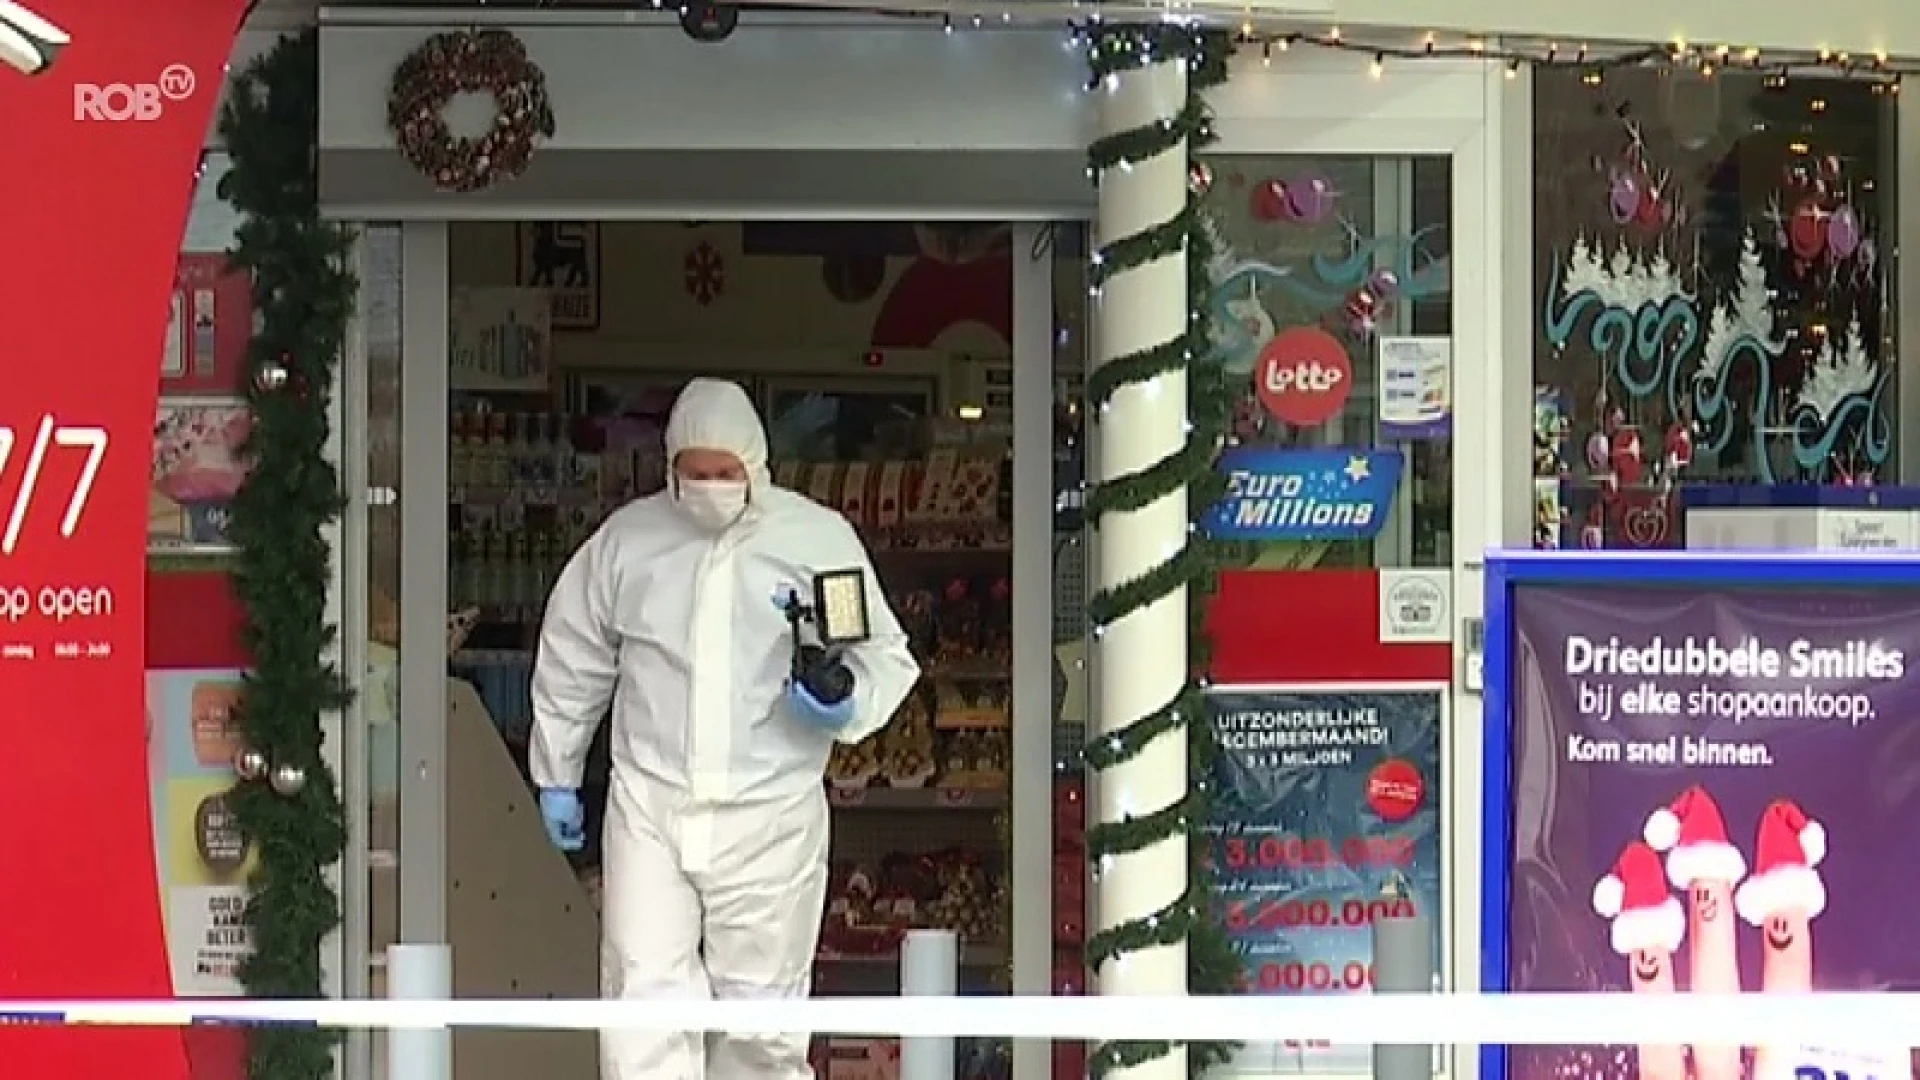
[{"x1": 321, "y1": 20, "x2": 1091, "y2": 154}]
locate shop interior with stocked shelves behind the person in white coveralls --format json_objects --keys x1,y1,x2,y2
[{"x1": 412, "y1": 221, "x2": 1085, "y2": 1080}]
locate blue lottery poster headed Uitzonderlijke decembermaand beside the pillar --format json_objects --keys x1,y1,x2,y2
[{"x1": 1208, "y1": 684, "x2": 1446, "y2": 1074}]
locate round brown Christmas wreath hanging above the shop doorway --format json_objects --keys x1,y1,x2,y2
[{"x1": 386, "y1": 31, "x2": 553, "y2": 192}]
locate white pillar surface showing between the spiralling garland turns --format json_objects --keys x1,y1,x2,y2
[{"x1": 1091, "y1": 37, "x2": 1188, "y2": 1080}]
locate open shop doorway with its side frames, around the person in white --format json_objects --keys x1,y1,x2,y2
[{"x1": 355, "y1": 219, "x2": 1087, "y2": 1080}]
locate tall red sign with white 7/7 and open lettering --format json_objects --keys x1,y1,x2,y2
[{"x1": 0, "y1": 0, "x2": 246, "y2": 1080}]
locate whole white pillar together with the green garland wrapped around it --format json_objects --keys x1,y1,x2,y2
[{"x1": 1085, "y1": 23, "x2": 1240, "y2": 1080}]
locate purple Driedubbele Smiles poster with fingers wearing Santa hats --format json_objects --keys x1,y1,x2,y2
[{"x1": 1507, "y1": 586, "x2": 1920, "y2": 1080}]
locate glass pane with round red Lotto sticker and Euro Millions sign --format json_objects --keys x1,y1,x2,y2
[{"x1": 1204, "y1": 154, "x2": 1453, "y2": 569}]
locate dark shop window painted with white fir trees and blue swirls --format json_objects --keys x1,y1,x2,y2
[{"x1": 1534, "y1": 69, "x2": 1899, "y2": 548}]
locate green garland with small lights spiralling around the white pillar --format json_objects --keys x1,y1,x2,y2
[{"x1": 1083, "y1": 23, "x2": 1244, "y2": 1076}]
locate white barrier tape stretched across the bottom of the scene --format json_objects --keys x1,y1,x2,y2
[{"x1": 0, "y1": 994, "x2": 1920, "y2": 1045}]
